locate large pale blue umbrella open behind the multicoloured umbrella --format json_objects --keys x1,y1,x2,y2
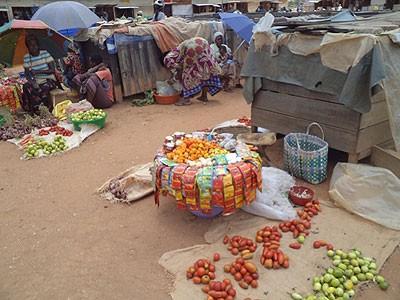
[{"x1": 32, "y1": 1, "x2": 100, "y2": 31}]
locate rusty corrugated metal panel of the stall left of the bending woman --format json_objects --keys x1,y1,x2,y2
[{"x1": 115, "y1": 34, "x2": 170, "y2": 97}]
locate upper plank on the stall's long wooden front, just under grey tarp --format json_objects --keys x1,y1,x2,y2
[{"x1": 253, "y1": 91, "x2": 360, "y2": 132}]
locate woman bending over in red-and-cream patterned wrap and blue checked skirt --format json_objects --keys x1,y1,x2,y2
[{"x1": 164, "y1": 37, "x2": 222, "y2": 105}]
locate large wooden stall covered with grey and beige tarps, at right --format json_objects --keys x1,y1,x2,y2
[{"x1": 242, "y1": 13, "x2": 400, "y2": 161}]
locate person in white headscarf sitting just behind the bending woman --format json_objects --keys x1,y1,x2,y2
[{"x1": 211, "y1": 32, "x2": 236, "y2": 91}]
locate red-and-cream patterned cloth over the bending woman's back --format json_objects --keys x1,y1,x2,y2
[{"x1": 164, "y1": 37, "x2": 221, "y2": 89}]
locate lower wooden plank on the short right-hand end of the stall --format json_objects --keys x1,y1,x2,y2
[{"x1": 356, "y1": 121, "x2": 392, "y2": 153}]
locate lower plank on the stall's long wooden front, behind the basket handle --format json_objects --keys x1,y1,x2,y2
[{"x1": 251, "y1": 107, "x2": 357, "y2": 153}]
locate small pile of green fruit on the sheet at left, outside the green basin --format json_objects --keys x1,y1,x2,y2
[{"x1": 24, "y1": 135, "x2": 68, "y2": 158}]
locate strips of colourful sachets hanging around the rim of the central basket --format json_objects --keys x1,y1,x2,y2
[{"x1": 154, "y1": 152, "x2": 262, "y2": 214}]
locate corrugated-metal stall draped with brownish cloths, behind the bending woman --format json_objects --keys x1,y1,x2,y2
[{"x1": 77, "y1": 17, "x2": 224, "y2": 100}]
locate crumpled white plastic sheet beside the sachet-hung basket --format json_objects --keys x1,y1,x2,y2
[{"x1": 242, "y1": 167, "x2": 296, "y2": 220}]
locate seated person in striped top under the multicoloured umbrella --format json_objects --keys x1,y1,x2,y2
[{"x1": 21, "y1": 34, "x2": 57, "y2": 113}]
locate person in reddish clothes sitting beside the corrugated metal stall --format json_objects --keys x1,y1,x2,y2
[{"x1": 72, "y1": 54, "x2": 115, "y2": 108}]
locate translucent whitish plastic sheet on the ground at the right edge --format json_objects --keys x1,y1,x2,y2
[{"x1": 329, "y1": 163, "x2": 400, "y2": 230}]
